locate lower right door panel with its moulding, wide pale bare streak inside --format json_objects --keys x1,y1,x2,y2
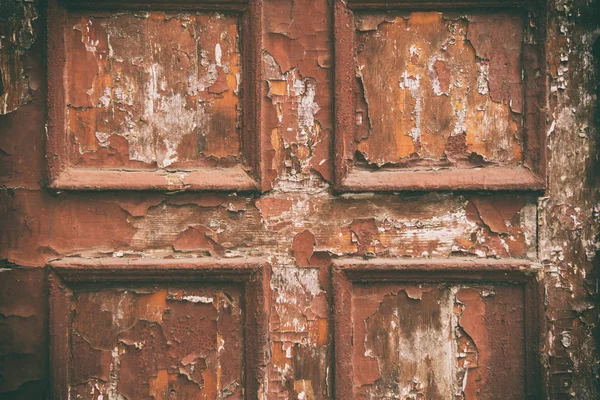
[{"x1": 334, "y1": 260, "x2": 538, "y2": 400}]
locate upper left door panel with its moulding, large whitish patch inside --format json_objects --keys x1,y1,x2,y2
[{"x1": 48, "y1": 0, "x2": 256, "y2": 190}]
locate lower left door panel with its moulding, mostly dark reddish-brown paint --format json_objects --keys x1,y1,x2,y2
[{"x1": 50, "y1": 260, "x2": 265, "y2": 399}]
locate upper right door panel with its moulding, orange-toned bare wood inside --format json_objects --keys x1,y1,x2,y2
[{"x1": 336, "y1": 1, "x2": 545, "y2": 190}]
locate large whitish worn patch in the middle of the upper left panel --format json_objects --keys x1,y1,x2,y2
[{"x1": 91, "y1": 20, "x2": 241, "y2": 168}]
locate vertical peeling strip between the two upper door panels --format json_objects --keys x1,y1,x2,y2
[{"x1": 263, "y1": 0, "x2": 333, "y2": 186}]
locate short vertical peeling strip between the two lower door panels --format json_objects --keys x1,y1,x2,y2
[{"x1": 266, "y1": 263, "x2": 332, "y2": 399}]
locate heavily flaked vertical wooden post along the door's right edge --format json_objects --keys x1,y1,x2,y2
[{"x1": 538, "y1": 0, "x2": 600, "y2": 399}]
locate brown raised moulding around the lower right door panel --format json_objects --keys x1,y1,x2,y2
[{"x1": 331, "y1": 258, "x2": 544, "y2": 400}]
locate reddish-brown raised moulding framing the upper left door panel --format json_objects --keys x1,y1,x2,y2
[{"x1": 46, "y1": 0, "x2": 263, "y2": 191}]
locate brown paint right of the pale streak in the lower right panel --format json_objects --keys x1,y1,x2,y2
[{"x1": 455, "y1": 285, "x2": 532, "y2": 399}]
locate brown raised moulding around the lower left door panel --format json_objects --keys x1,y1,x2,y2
[{"x1": 48, "y1": 257, "x2": 270, "y2": 399}]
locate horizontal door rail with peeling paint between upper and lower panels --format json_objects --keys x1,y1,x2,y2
[{"x1": 0, "y1": 190, "x2": 536, "y2": 266}]
